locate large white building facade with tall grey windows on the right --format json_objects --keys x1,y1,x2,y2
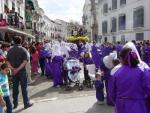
[{"x1": 98, "y1": 0, "x2": 150, "y2": 43}]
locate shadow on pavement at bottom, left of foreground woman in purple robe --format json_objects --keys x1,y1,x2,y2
[{"x1": 85, "y1": 103, "x2": 113, "y2": 113}]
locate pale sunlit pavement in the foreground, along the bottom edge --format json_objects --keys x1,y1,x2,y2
[{"x1": 15, "y1": 96, "x2": 113, "y2": 113}]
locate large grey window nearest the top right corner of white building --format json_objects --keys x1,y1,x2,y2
[{"x1": 133, "y1": 7, "x2": 144, "y2": 28}]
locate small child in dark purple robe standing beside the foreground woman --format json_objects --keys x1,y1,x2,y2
[{"x1": 95, "y1": 73, "x2": 104, "y2": 105}]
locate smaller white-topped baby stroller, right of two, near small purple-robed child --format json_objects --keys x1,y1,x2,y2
[{"x1": 83, "y1": 64, "x2": 96, "y2": 88}]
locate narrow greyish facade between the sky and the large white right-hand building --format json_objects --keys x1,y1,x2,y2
[{"x1": 82, "y1": 0, "x2": 99, "y2": 41}]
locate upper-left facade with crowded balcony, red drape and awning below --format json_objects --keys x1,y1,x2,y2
[{"x1": 0, "y1": 0, "x2": 32, "y2": 42}]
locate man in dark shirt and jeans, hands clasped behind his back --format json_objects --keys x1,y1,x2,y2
[{"x1": 7, "y1": 36, "x2": 33, "y2": 109}]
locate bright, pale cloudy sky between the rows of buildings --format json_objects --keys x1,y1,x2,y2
[{"x1": 38, "y1": 0, "x2": 85, "y2": 23}]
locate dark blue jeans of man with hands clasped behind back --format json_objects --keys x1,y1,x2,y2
[{"x1": 13, "y1": 70, "x2": 29, "y2": 106}]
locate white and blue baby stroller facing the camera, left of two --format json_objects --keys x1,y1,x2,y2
[{"x1": 64, "y1": 58, "x2": 83, "y2": 90}]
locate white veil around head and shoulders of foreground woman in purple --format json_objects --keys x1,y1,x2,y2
[{"x1": 111, "y1": 42, "x2": 150, "y2": 76}]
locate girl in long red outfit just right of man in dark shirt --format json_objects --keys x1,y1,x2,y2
[{"x1": 31, "y1": 47, "x2": 39, "y2": 75}]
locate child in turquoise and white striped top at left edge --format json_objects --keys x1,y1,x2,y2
[{"x1": 0, "y1": 63, "x2": 12, "y2": 113}]
